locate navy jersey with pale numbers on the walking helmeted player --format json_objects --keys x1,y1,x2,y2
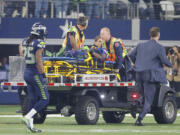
[{"x1": 22, "y1": 39, "x2": 45, "y2": 66}]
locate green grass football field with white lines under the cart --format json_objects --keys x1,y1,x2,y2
[{"x1": 0, "y1": 106, "x2": 180, "y2": 135}]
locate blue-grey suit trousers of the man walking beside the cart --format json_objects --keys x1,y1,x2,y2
[{"x1": 136, "y1": 71, "x2": 156, "y2": 120}]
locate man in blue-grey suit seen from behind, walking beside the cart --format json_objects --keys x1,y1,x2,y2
[{"x1": 130, "y1": 27, "x2": 172, "y2": 126}]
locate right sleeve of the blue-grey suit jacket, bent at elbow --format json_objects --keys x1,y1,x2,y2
[{"x1": 159, "y1": 47, "x2": 172, "y2": 67}]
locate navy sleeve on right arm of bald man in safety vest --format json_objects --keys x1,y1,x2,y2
[{"x1": 114, "y1": 42, "x2": 123, "y2": 69}]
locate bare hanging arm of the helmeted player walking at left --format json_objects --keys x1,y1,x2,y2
[{"x1": 35, "y1": 48, "x2": 44, "y2": 74}]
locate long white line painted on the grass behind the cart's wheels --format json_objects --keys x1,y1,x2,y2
[{"x1": 0, "y1": 113, "x2": 180, "y2": 118}]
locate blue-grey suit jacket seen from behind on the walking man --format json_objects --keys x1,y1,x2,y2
[{"x1": 129, "y1": 40, "x2": 172, "y2": 83}]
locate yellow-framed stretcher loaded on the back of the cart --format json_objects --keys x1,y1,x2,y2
[{"x1": 43, "y1": 54, "x2": 121, "y2": 82}]
